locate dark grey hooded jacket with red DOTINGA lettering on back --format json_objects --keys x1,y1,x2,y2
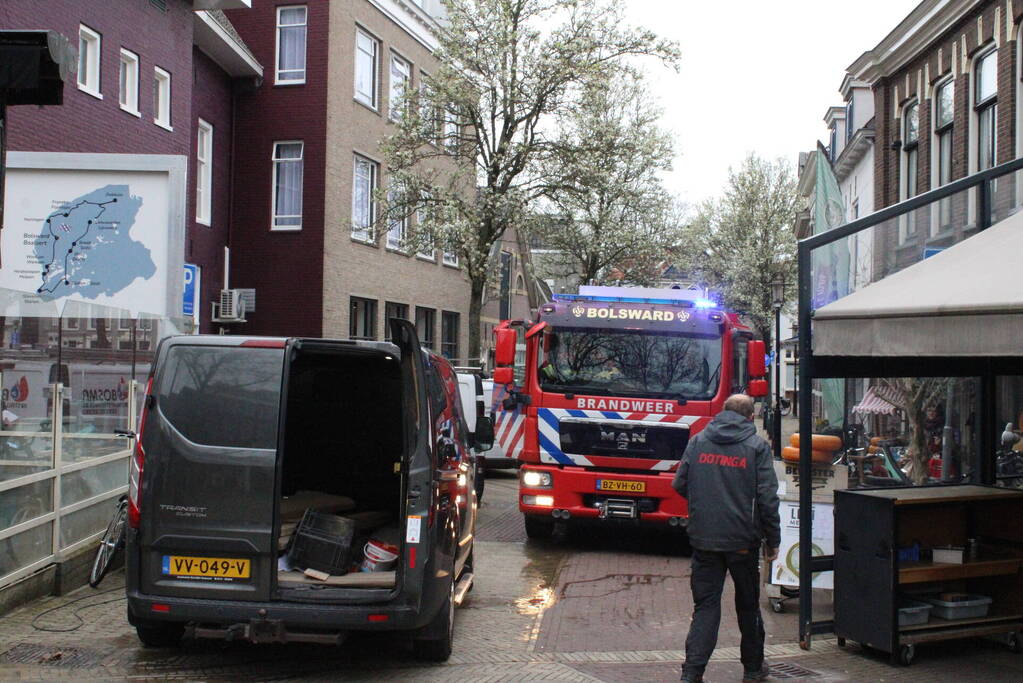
[{"x1": 672, "y1": 410, "x2": 782, "y2": 552}]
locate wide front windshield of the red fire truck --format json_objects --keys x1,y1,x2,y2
[{"x1": 539, "y1": 328, "x2": 721, "y2": 401}]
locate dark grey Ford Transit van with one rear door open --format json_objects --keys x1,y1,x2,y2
[{"x1": 126, "y1": 320, "x2": 493, "y2": 661}]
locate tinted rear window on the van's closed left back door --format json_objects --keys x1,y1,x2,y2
[{"x1": 157, "y1": 346, "x2": 284, "y2": 449}]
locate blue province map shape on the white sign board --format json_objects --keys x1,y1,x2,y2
[{"x1": 35, "y1": 185, "x2": 157, "y2": 301}]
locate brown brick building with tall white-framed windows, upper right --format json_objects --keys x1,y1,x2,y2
[{"x1": 848, "y1": 0, "x2": 1023, "y2": 278}]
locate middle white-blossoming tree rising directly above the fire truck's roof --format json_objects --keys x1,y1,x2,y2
[{"x1": 534, "y1": 72, "x2": 682, "y2": 284}]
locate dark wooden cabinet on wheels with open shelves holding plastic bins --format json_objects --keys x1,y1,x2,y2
[{"x1": 835, "y1": 486, "x2": 1023, "y2": 665}]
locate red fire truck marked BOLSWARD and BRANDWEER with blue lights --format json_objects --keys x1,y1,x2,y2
[{"x1": 492, "y1": 286, "x2": 767, "y2": 538}]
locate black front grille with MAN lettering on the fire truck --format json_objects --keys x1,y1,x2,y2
[{"x1": 559, "y1": 420, "x2": 690, "y2": 460}]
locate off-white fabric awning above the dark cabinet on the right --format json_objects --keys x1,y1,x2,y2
[{"x1": 813, "y1": 212, "x2": 1023, "y2": 357}]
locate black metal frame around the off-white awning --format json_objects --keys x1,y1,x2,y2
[{"x1": 798, "y1": 153, "x2": 1023, "y2": 649}]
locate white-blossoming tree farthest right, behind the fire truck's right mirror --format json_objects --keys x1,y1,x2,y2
[{"x1": 680, "y1": 154, "x2": 796, "y2": 348}]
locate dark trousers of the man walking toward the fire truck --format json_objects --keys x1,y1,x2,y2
[{"x1": 684, "y1": 548, "x2": 764, "y2": 674}]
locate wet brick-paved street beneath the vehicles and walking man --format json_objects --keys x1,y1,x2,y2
[{"x1": 6, "y1": 472, "x2": 1023, "y2": 683}]
